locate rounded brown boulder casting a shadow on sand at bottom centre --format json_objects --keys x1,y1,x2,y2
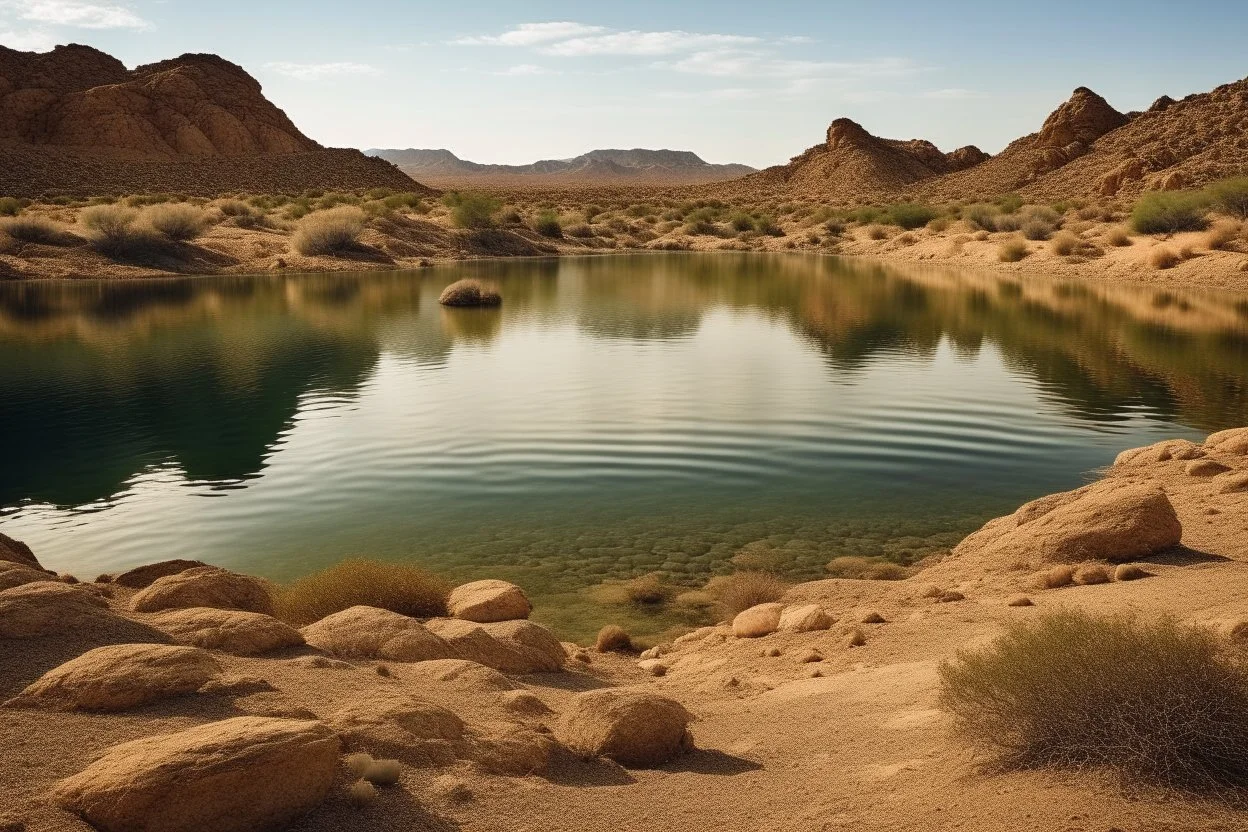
[{"x1": 555, "y1": 687, "x2": 693, "y2": 768}]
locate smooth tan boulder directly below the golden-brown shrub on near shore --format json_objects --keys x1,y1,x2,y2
[{"x1": 302, "y1": 606, "x2": 454, "y2": 661}]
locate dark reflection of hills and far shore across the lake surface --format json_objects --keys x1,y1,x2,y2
[{"x1": 0, "y1": 254, "x2": 1248, "y2": 505}]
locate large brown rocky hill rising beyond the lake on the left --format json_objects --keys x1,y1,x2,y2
[{"x1": 0, "y1": 45, "x2": 414, "y2": 196}]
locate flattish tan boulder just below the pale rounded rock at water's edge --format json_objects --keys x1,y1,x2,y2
[{"x1": 428, "y1": 619, "x2": 568, "y2": 674}]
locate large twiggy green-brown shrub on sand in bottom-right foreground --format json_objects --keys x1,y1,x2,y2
[{"x1": 940, "y1": 611, "x2": 1248, "y2": 790}]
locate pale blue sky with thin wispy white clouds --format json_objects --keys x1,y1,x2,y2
[{"x1": 0, "y1": 0, "x2": 1248, "y2": 167}]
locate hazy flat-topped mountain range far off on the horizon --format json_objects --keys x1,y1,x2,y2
[{"x1": 364, "y1": 148, "x2": 755, "y2": 187}]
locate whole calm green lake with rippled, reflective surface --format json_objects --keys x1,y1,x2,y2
[{"x1": 0, "y1": 254, "x2": 1248, "y2": 634}]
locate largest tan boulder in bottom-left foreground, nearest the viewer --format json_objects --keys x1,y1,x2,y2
[{"x1": 52, "y1": 716, "x2": 341, "y2": 832}]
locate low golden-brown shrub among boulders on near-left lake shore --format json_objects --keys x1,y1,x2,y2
[{"x1": 272, "y1": 558, "x2": 451, "y2": 626}]
